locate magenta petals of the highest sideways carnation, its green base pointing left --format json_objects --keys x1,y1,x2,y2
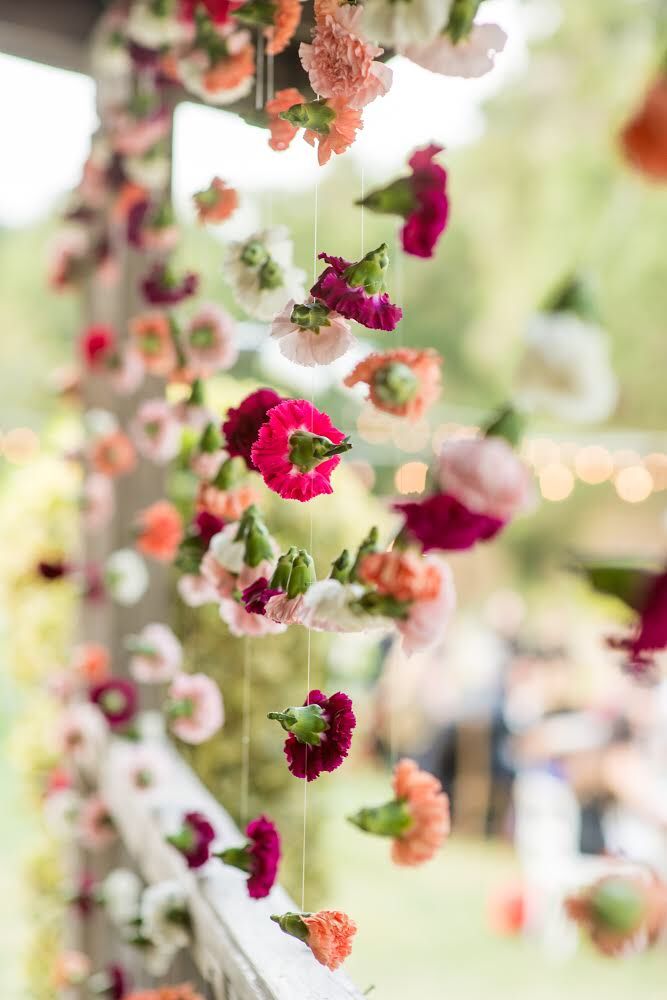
[{"x1": 401, "y1": 145, "x2": 449, "y2": 257}]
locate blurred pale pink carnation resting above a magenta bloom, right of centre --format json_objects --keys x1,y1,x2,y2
[{"x1": 438, "y1": 437, "x2": 535, "y2": 521}]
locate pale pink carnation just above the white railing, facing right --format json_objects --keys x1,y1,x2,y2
[{"x1": 165, "y1": 674, "x2": 225, "y2": 745}]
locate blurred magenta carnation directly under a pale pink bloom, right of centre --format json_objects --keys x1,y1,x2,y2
[{"x1": 394, "y1": 493, "x2": 506, "y2": 552}]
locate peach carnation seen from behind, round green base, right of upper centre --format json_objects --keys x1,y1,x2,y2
[{"x1": 344, "y1": 347, "x2": 442, "y2": 420}]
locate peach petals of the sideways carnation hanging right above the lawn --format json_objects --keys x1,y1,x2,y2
[{"x1": 391, "y1": 758, "x2": 450, "y2": 865}]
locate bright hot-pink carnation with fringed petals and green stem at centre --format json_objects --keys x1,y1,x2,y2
[{"x1": 251, "y1": 399, "x2": 351, "y2": 502}]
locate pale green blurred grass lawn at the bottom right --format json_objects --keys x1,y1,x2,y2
[{"x1": 318, "y1": 772, "x2": 667, "y2": 1000}]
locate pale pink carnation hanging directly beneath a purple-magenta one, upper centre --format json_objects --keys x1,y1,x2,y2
[{"x1": 271, "y1": 299, "x2": 354, "y2": 368}]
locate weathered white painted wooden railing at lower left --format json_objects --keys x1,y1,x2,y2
[{"x1": 97, "y1": 720, "x2": 362, "y2": 1000}]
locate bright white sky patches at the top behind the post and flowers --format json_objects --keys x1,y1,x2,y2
[{"x1": 0, "y1": 0, "x2": 560, "y2": 229}]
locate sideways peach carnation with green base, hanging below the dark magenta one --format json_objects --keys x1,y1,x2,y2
[{"x1": 350, "y1": 758, "x2": 450, "y2": 865}]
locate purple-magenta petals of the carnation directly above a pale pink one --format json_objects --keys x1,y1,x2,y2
[{"x1": 310, "y1": 253, "x2": 403, "y2": 330}]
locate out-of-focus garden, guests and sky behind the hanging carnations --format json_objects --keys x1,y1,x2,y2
[{"x1": 0, "y1": 0, "x2": 667, "y2": 1000}]
